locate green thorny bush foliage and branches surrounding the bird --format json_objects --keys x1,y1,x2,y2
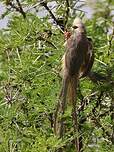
[{"x1": 0, "y1": 0, "x2": 114, "y2": 152}]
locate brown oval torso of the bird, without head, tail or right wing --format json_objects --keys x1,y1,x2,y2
[{"x1": 65, "y1": 36, "x2": 88, "y2": 75}]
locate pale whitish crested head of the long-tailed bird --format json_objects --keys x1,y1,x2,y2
[{"x1": 72, "y1": 18, "x2": 86, "y2": 34}]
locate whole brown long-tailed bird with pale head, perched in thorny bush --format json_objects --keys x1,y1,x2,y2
[{"x1": 54, "y1": 18, "x2": 94, "y2": 152}]
